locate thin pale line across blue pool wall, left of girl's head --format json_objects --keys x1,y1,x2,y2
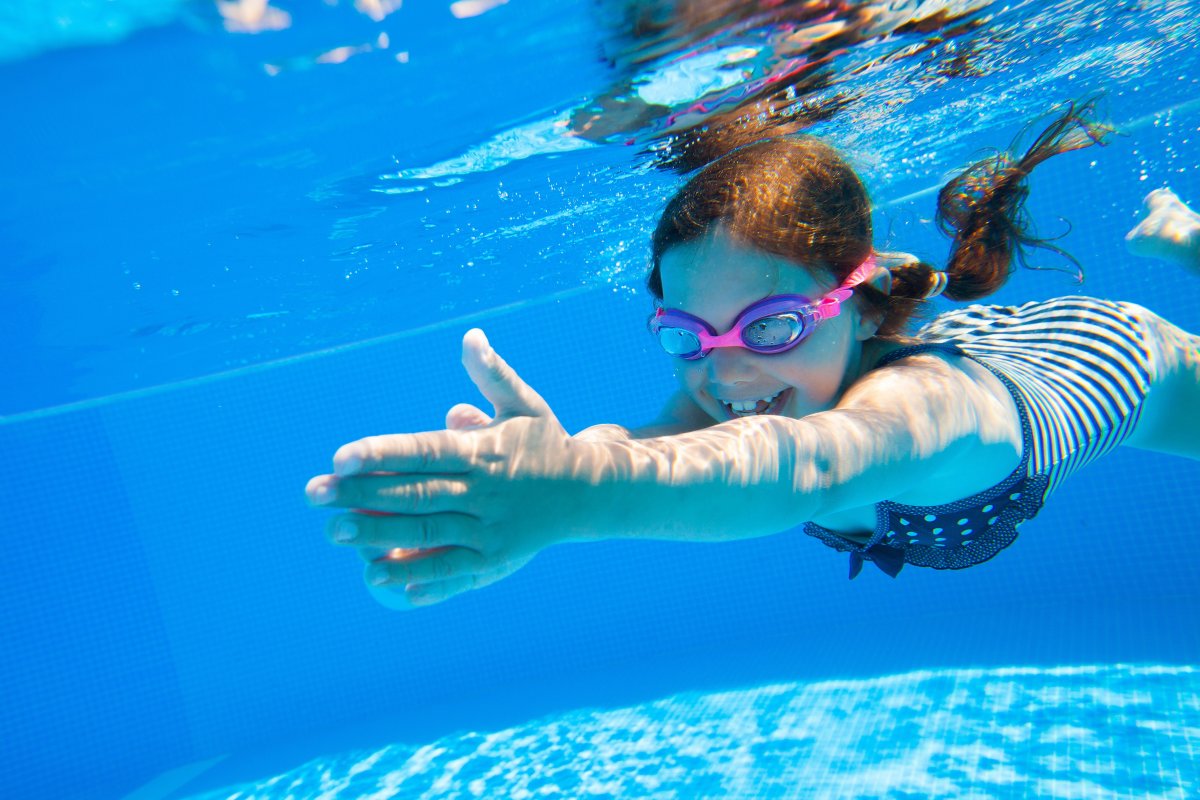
[{"x1": 0, "y1": 284, "x2": 595, "y2": 428}]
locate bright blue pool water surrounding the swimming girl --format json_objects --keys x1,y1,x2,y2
[{"x1": 0, "y1": 0, "x2": 1200, "y2": 800}]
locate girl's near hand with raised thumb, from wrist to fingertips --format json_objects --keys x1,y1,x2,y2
[{"x1": 306, "y1": 329, "x2": 599, "y2": 608}]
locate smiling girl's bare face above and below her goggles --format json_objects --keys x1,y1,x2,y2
[{"x1": 660, "y1": 225, "x2": 876, "y2": 422}]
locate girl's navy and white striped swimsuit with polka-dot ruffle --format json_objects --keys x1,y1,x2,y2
[{"x1": 804, "y1": 296, "x2": 1153, "y2": 578}]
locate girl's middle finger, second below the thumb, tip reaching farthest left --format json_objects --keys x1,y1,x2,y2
[{"x1": 305, "y1": 475, "x2": 468, "y2": 515}]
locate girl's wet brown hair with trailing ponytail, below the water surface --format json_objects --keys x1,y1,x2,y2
[{"x1": 647, "y1": 98, "x2": 1112, "y2": 337}]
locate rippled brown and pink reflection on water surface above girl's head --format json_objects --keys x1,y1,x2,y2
[{"x1": 378, "y1": 0, "x2": 998, "y2": 187}]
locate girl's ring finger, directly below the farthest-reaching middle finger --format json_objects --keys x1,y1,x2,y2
[{"x1": 325, "y1": 513, "x2": 479, "y2": 549}]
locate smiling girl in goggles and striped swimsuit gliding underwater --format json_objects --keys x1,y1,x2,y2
[{"x1": 307, "y1": 104, "x2": 1200, "y2": 608}]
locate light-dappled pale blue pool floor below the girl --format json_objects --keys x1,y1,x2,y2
[{"x1": 182, "y1": 664, "x2": 1200, "y2": 800}]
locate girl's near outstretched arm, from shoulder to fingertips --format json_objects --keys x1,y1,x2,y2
[{"x1": 307, "y1": 331, "x2": 1020, "y2": 603}]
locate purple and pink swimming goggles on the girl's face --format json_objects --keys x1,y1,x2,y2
[{"x1": 650, "y1": 257, "x2": 875, "y2": 361}]
